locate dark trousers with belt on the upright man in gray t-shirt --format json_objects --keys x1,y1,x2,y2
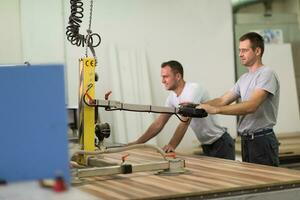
[{"x1": 241, "y1": 132, "x2": 279, "y2": 167}]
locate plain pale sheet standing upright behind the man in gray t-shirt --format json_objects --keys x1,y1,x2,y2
[{"x1": 263, "y1": 44, "x2": 300, "y2": 134}]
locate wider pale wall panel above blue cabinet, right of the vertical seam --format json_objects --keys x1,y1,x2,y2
[{"x1": 20, "y1": 0, "x2": 65, "y2": 63}]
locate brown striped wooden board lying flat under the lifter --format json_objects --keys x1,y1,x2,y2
[{"x1": 77, "y1": 149, "x2": 300, "y2": 200}]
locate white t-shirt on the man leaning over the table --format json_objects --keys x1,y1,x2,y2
[{"x1": 166, "y1": 82, "x2": 225, "y2": 144}]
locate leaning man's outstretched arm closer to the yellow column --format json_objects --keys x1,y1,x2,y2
[{"x1": 129, "y1": 114, "x2": 171, "y2": 145}]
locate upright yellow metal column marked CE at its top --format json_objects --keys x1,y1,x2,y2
[{"x1": 78, "y1": 58, "x2": 96, "y2": 165}]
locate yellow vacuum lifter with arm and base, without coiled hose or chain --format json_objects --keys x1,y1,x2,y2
[{"x1": 73, "y1": 58, "x2": 207, "y2": 178}]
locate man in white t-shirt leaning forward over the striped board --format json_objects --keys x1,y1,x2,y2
[{"x1": 129, "y1": 60, "x2": 235, "y2": 160}]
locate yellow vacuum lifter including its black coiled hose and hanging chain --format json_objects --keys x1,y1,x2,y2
[{"x1": 66, "y1": 0, "x2": 207, "y2": 181}]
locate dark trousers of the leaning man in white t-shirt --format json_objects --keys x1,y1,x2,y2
[{"x1": 201, "y1": 132, "x2": 235, "y2": 160}]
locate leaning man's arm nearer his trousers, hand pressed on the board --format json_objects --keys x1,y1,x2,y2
[{"x1": 163, "y1": 118, "x2": 191, "y2": 153}]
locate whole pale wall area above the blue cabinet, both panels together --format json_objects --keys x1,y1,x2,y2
[{"x1": 0, "y1": 0, "x2": 65, "y2": 64}]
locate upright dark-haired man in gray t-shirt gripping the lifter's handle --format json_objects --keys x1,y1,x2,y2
[{"x1": 199, "y1": 32, "x2": 280, "y2": 166}]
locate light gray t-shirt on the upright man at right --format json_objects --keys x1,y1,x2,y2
[{"x1": 231, "y1": 66, "x2": 280, "y2": 134}]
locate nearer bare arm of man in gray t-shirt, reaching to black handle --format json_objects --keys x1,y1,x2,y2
[{"x1": 198, "y1": 89, "x2": 269, "y2": 115}]
